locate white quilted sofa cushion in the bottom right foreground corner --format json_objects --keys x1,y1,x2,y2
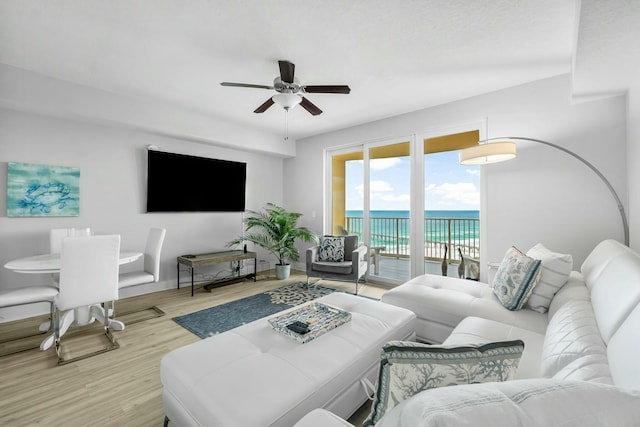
[{"x1": 376, "y1": 378, "x2": 640, "y2": 427}]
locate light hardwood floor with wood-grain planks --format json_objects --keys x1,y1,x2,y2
[{"x1": 0, "y1": 271, "x2": 387, "y2": 427}]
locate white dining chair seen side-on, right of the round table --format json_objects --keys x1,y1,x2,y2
[{"x1": 118, "y1": 227, "x2": 167, "y2": 324}]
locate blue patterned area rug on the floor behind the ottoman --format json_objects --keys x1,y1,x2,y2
[{"x1": 173, "y1": 282, "x2": 341, "y2": 338}]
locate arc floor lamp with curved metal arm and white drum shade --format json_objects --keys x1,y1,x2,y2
[{"x1": 460, "y1": 136, "x2": 629, "y2": 246}]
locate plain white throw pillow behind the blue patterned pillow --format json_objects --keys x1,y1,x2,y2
[{"x1": 525, "y1": 243, "x2": 573, "y2": 313}]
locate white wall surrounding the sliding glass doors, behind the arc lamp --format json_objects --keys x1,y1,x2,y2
[{"x1": 284, "y1": 75, "x2": 627, "y2": 278}]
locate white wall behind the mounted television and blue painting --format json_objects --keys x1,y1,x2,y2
[{"x1": 0, "y1": 108, "x2": 283, "y2": 321}]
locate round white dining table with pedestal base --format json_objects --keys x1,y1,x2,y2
[{"x1": 4, "y1": 251, "x2": 144, "y2": 350}]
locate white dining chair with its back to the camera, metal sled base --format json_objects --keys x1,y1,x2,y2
[{"x1": 46, "y1": 235, "x2": 120, "y2": 365}]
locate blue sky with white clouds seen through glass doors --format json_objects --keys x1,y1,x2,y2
[{"x1": 346, "y1": 151, "x2": 480, "y2": 210}]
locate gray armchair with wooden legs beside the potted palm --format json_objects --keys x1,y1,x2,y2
[{"x1": 306, "y1": 235, "x2": 369, "y2": 295}]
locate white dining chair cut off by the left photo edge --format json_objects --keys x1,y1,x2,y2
[{"x1": 0, "y1": 286, "x2": 58, "y2": 357}]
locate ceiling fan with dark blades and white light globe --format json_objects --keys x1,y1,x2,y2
[{"x1": 220, "y1": 61, "x2": 351, "y2": 116}]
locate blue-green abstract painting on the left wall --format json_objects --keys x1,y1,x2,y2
[{"x1": 7, "y1": 162, "x2": 80, "y2": 217}]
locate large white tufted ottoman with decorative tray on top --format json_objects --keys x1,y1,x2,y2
[{"x1": 160, "y1": 292, "x2": 415, "y2": 427}]
